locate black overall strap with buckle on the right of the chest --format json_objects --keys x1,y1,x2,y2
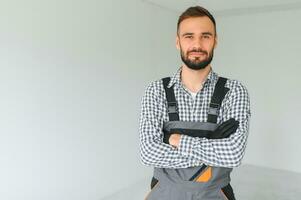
[{"x1": 207, "y1": 77, "x2": 229, "y2": 123}]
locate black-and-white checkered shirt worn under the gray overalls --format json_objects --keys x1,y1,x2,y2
[{"x1": 139, "y1": 67, "x2": 251, "y2": 169}]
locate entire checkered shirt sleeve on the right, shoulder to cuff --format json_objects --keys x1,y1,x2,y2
[{"x1": 178, "y1": 80, "x2": 251, "y2": 168}]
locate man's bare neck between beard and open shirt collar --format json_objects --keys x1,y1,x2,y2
[{"x1": 181, "y1": 65, "x2": 211, "y2": 92}]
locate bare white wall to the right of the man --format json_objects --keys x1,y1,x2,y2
[{"x1": 214, "y1": 10, "x2": 301, "y2": 172}]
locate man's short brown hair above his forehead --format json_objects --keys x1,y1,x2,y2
[{"x1": 177, "y1": 6, "x2": 216, "y2": 34}]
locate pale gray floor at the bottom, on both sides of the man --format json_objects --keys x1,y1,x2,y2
[{"x1": 101, "y1": 165, "x2": 301, "y2": 200}]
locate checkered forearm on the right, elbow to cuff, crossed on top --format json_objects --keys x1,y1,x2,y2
[{"x1": 178, "y1": 119, "x2": 249, "y2": 168}]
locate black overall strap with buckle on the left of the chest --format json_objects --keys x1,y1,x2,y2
[{"x1": 162, "y1": 77, "x2": 180, "y2": 121}]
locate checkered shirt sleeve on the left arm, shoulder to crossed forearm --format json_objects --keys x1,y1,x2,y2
[{"x1": 139, "y1": 80, "x2": 192, "y2": 168}]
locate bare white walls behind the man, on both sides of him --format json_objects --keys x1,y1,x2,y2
[{"x1": 0, "y1": 0, "x2": 301, "y2": 200}]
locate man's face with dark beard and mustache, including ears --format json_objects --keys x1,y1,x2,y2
[{"x1": 176, "y1": 16, "x2": 217, "y2": 70}]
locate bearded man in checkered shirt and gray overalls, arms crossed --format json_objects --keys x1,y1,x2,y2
[{"x1": 139, "y1": 6, "x2": 251, "y2": 200}]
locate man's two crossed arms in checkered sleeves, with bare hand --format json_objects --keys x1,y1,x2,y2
[{"x1": 139, "y1": 80, "x2": 251, "y2": 168}]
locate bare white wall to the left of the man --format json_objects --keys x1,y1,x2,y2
[{"x1": 0, "y1": 0, "x2": 176, "y2": 200}]
